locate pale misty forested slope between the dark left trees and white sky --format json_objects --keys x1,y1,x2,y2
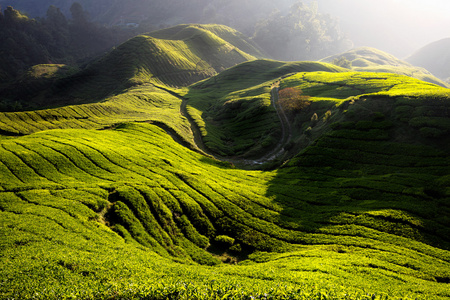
[{"x1": 96, "y1": 0, "x2": 352, "y2": 61}]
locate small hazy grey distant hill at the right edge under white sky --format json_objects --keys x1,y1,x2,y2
[{"x1": 406, "y1": 38, "x2": 450, "y2": 80}]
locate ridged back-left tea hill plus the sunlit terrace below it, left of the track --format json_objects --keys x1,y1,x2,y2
[{"x1": 0, "y1": 25, "x2": 266, "y2": 147}]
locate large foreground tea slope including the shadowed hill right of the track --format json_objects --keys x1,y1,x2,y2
[{"x1": 0, "y1": 67, "x2": 450, "y2": 299}]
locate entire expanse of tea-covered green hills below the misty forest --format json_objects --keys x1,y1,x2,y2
[{"x1": 0, "y1": 25, "x2": 450, "y2": 300}]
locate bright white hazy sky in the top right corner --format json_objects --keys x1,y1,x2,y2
[{"x1": 318, "y1": 0, "x2": 450, "y2": 58}]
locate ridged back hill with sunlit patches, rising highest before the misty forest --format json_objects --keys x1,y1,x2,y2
[{"x1": 99, "y1": 27, "x2": 254, "y2": 86}]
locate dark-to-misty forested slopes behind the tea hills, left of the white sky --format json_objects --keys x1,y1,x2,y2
[{"x1": 0, "y1": 0, "x2": 352, "y2": 76}]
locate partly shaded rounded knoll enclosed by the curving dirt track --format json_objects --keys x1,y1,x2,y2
[{"x1": 185, "y1": 60, "x2": 345, "y2": 157}]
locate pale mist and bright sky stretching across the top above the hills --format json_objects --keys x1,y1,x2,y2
[{"x1": 0, "y1": 0, "x2": 450, "y2": 60}]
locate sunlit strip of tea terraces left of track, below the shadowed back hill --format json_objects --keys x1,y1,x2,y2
[{"x1": 0, "y1": 85, "x2": 194, "y2": 147}]
